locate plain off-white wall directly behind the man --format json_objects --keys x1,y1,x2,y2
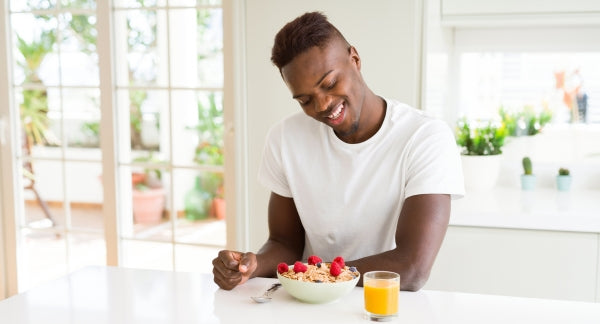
[{"x1": 245, "y1": 0, "x2": 422, "y2": 251}]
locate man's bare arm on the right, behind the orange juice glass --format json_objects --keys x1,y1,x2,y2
[{"x1": 346, "y1": 194, "x2": 450, "y2": 291}]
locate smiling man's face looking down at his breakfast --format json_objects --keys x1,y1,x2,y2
[{"x1": 281, "y1": 39, "x2": 366, "y2": 142}]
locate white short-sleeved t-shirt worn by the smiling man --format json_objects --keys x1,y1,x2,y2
[{"x1": 258, "y1": 99, "x2": 464, "y2": 261}]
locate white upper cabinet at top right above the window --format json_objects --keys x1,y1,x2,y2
[{"x1": 440, "y1": 0, "x2": 600, "y2": 25}]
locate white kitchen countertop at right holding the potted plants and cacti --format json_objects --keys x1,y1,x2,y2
[{"x1": 450, "y1": 187, "x2": 600, "y2": 233}]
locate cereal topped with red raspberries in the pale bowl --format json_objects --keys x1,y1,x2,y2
[{"x1": 277, "y1": 255, "x2": 359, "y2": 283}]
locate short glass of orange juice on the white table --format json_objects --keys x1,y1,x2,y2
[{"x1": 363, "y1": 271, "x2": 400, "y2": 321}]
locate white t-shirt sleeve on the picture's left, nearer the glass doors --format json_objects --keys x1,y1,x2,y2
[{"x1": 258, "y1": 123, "x2": 292, "y2": 197}]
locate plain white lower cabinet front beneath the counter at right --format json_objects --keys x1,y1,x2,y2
[{"x1": 425, "y1": 226, "x2": 600, "y2": 301}]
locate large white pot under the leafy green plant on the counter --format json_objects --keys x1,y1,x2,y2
[{"x1": 461, "y1": 154, "x2": 502, "y2": 191}]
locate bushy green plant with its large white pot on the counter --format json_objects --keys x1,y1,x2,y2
[{"x1": 456, "y1": 118, "x2": 506, "y2": 190}]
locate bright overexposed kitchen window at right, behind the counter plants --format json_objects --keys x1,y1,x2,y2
[{"x1": 459, "y1": 51, "x2": 600, "y2": 123}]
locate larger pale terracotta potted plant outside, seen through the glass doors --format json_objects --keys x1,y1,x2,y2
[{"x1": 131, "y1": 153, "x2": 166, "y2": 224}]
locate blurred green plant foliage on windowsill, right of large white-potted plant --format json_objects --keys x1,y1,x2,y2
[{"x1": 498, "y1": 106, "x2": 552, "y2": 136}]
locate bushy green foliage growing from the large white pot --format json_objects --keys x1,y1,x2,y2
[{"x1": 456, "y1": 118, "x2": 506, "y2": 155}]
